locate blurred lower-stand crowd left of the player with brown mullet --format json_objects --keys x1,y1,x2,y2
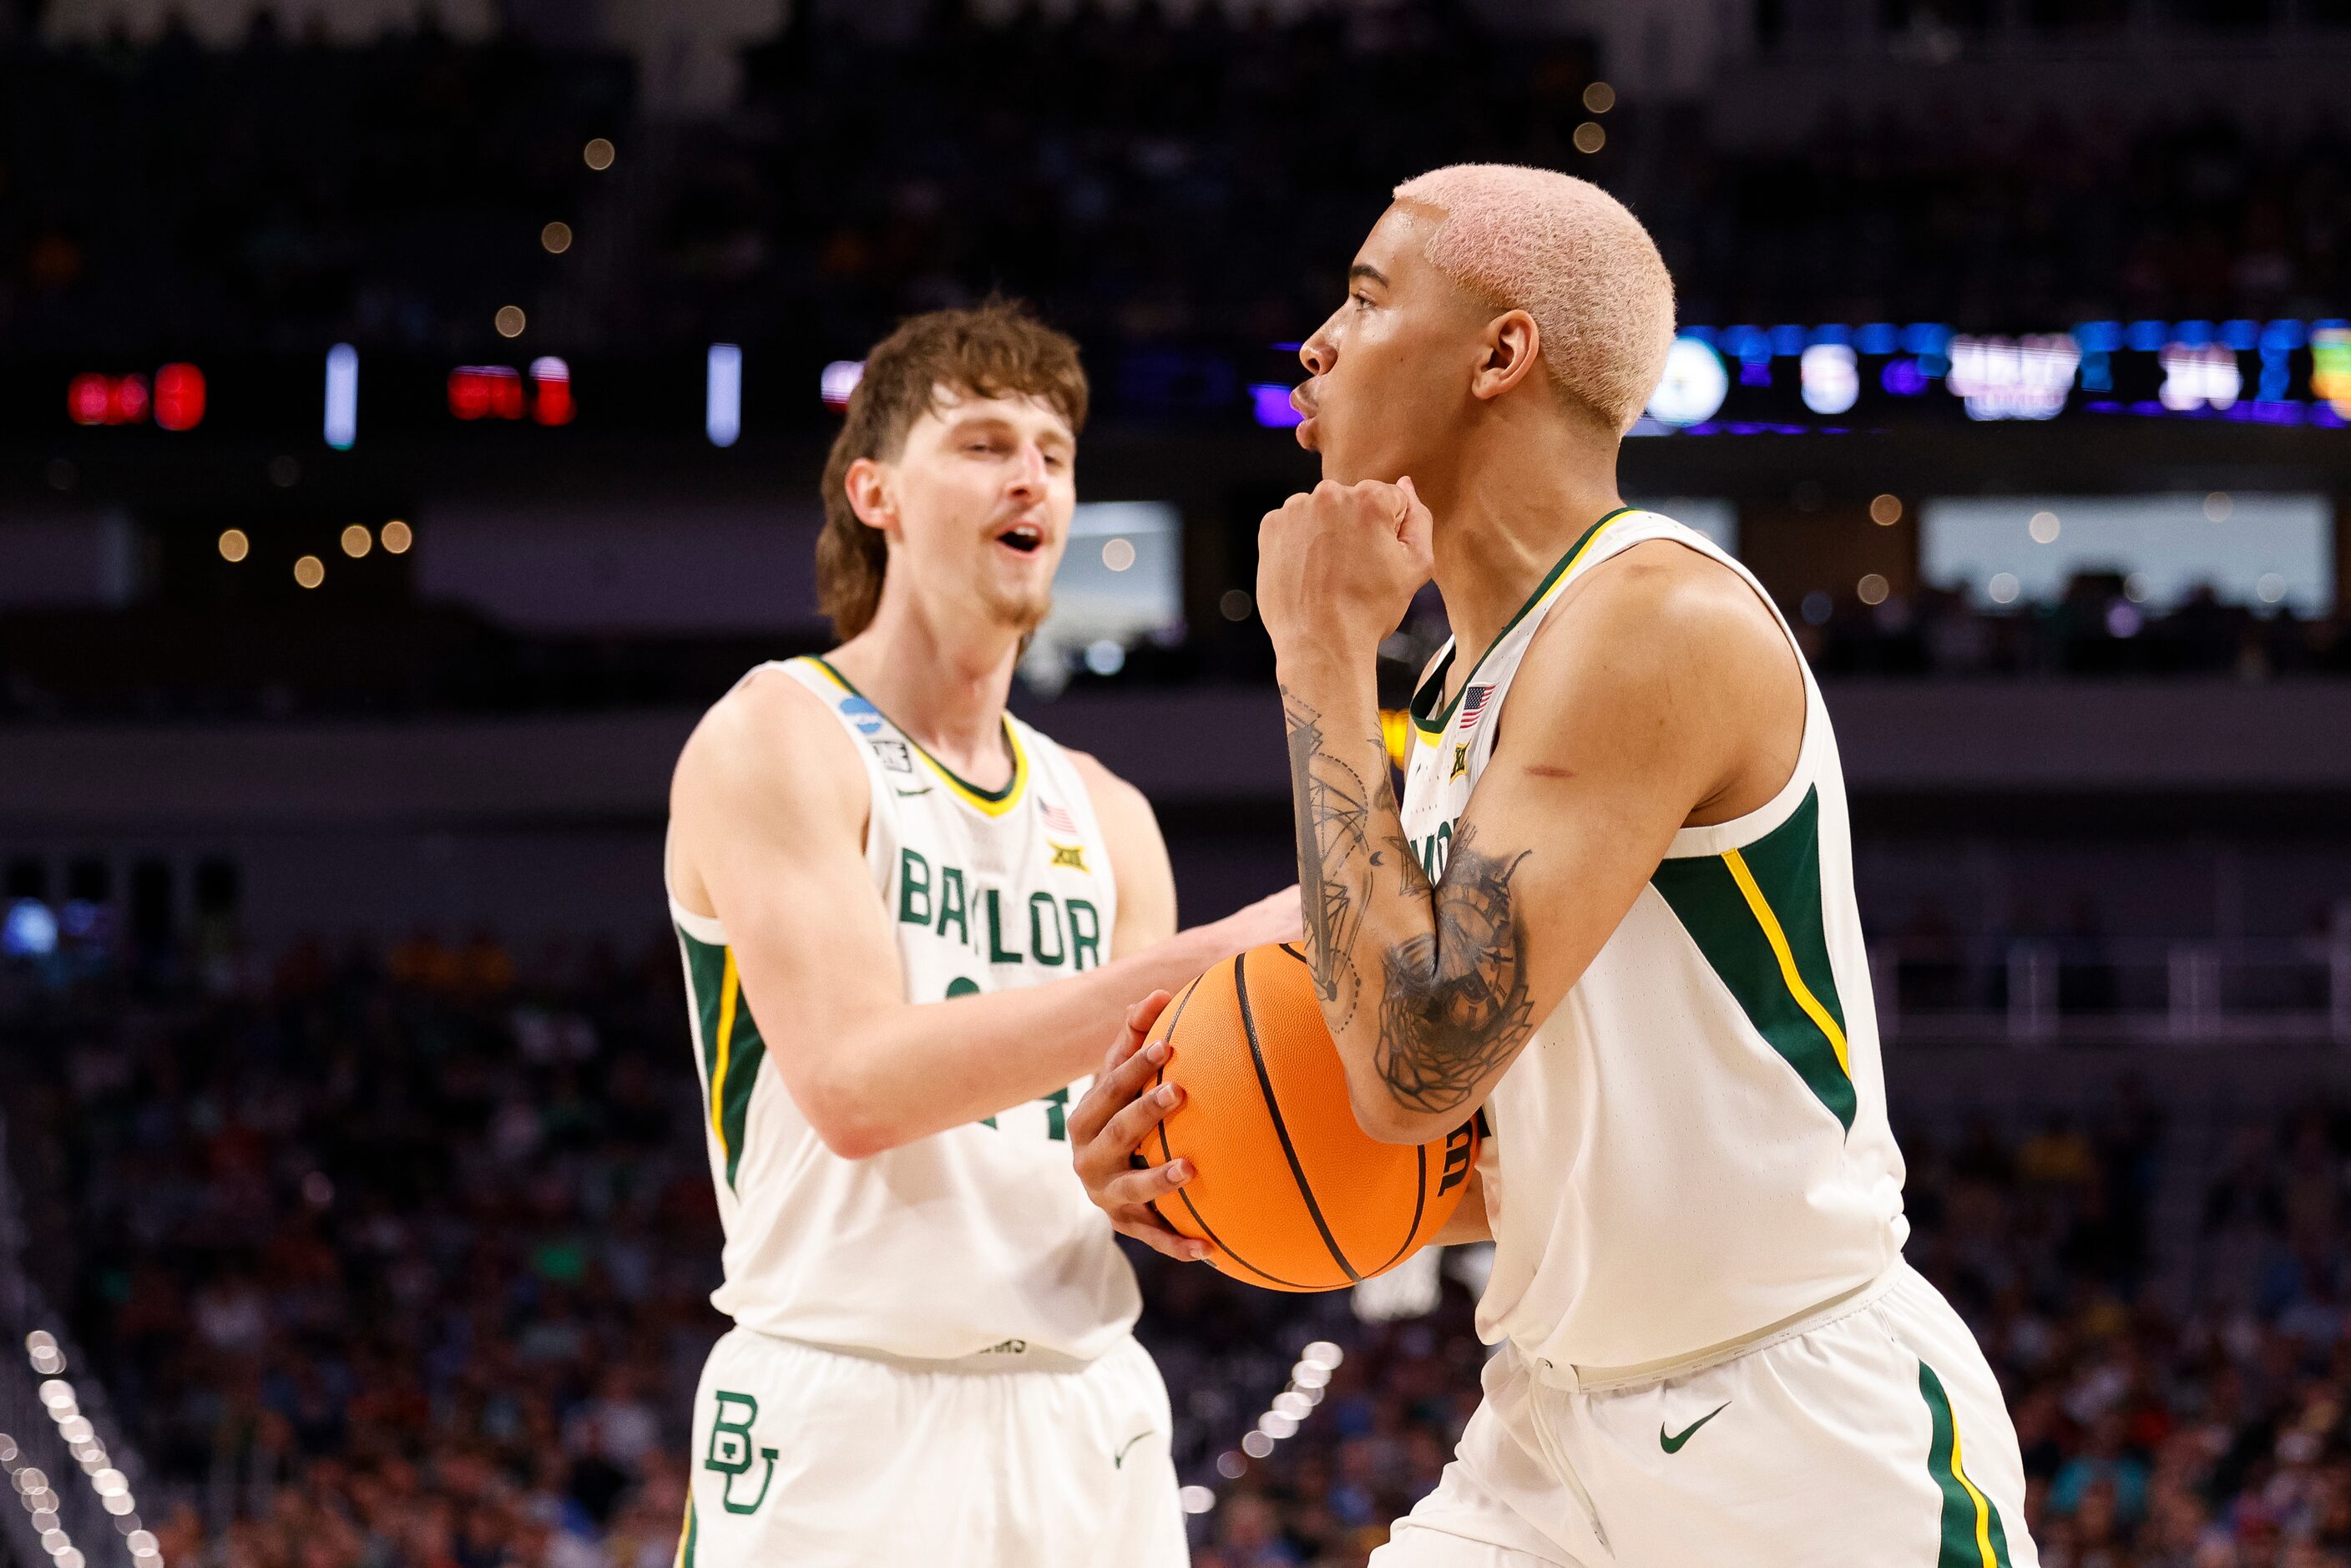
[{"x1": 0, "y1": 938, "x2": 722, "y2": 1568}]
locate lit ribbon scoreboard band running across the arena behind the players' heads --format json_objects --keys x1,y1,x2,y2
[{"x1": 13, "y1": 320, "x2": 2351, "y2": 452}]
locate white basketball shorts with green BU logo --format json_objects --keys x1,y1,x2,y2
[{"x1": 677, "y1": 1328, "x2": 1190, "y2": 1568}]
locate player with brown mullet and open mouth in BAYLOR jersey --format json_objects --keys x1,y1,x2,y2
[{"x1": 665, "y1": 306, "x2": 1297, "y2": 1568}]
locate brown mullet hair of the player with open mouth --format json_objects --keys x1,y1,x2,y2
[{"x1": 816, "y1": 299, "x2": 1086, "y2": 642}]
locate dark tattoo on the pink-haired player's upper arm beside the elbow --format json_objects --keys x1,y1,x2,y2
[{"x1": 1373, "y1": 822, "x2": 1535, "y2": 1112}]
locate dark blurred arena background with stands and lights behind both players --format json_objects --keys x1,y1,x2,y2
[{"x1": 0, "y1": 0, "x2": 2351, "y2": 1568}]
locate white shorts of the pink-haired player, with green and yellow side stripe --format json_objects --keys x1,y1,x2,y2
[{"x1": 1371, "y1": 1265, "x2": 2040, "y2": 1568}]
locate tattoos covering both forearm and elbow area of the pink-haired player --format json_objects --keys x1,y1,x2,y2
[{"x1": 1282, "y1": 689, "x2": 1535, "y2": 1112}]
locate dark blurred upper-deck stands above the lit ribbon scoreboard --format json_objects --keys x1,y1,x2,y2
[{"x1": 13, "y1": 0, "x2": 2351, "y2": 364}]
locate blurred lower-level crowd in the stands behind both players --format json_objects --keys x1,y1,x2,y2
[{"x1": 18, "y1": 938, "x2": 2351, "y2": 1568}]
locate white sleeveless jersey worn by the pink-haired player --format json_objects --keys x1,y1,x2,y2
[{"x1": 1403, "y1": 508, "x2": 1909, "y2": 1368}]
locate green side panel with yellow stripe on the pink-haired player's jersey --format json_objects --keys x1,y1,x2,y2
[{"x1": 1648, "y1": 790, "x2": 1859, "y2": 1133}]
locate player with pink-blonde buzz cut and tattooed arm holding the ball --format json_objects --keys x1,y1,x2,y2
[{"x1": 1072, "y1": 164, "x2": 2038, "y2": 1568}]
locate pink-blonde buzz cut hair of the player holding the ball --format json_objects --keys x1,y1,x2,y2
[{"x1": 1394, "y1": 162, "x2": 1674, "y2": 435}]
